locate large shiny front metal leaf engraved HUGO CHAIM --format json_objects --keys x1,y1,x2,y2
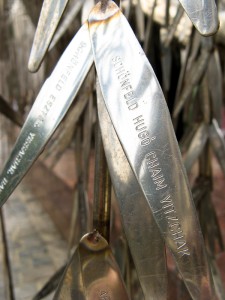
[{"x1": 89, "y1": 1, "x2": 214, "y2": 299}]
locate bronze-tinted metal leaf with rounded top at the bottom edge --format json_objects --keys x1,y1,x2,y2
[{"x1": 53, "y1": 231, "x2": 129, "y2": 300}]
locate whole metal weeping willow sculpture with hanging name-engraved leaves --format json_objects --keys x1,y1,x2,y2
[{"x1": 0, "y1": 0, "x2": 225, "y2": 300}]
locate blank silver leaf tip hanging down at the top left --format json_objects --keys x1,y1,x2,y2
[{"x1": 28, "y1": 0, "x2": 68, "y2": 72}]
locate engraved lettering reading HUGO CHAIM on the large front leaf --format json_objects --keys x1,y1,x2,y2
[{"x1": 112, "y1": 56, "x2": 190, "y2": 257}]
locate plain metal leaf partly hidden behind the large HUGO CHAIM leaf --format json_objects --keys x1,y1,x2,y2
[{"x1": 97, "y1": 84, "x2": 167, "y2": 300}]
